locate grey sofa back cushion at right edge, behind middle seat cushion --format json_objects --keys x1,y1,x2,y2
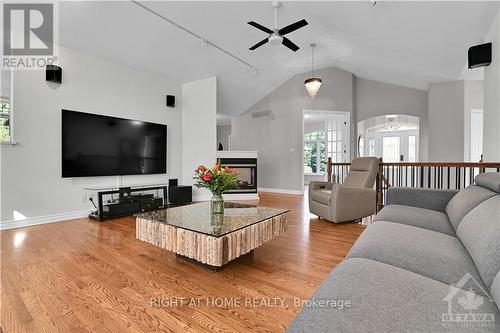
[{"x1": 457, "y1": 195, "x2": 500, "y2": 288}]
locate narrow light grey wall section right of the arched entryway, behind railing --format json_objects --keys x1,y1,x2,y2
[{"x1": 429, "y1": 81, "x2": 465, "y2": 162}]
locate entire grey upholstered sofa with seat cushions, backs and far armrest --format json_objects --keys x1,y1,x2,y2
[{"x1": 288, "y1": 173, "x2": 500, "y2": 333}]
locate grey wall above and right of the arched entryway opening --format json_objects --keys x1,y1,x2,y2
[{"x1": 355, "y1": 78, "x2": 428, "y2": 161}]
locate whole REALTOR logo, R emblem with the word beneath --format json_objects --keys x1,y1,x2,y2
[{"x1": 2, "y1": 0, "x2": 58, "y2": 69}]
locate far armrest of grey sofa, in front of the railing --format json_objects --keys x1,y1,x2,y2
[{"x1": 386, "y1": 187, "x2": 459, "y2": 212}]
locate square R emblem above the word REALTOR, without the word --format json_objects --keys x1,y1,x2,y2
[{"x1": 3, "y1": 3, "x2": 54, "y2": 56}]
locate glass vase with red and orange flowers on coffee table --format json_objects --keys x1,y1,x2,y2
[{"x1": 194, "y1": 163, "x2": 239, "y2": 214}]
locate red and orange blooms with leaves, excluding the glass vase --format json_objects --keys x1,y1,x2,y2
[{"x1": 194, "y1": 163, "x2": 239, "y2": 195}]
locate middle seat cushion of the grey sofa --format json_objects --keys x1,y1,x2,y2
[{"x1": 347, "y1": 221, "x2": 486, "y2": 294}]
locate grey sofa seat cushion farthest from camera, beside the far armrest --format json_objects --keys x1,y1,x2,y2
[{"x1": 374, "y1": 205, "x2": 455, "y2": 235}]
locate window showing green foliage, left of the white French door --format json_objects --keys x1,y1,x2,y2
[{"x1": 304, "y1": 131, "x2": 327, "y2": 174}]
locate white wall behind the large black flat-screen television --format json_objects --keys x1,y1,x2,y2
[{"x1": 1, "y1": 47, "x2": 182, "y2": 224}]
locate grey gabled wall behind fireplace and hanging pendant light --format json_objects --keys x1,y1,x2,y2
[{"x1": 231, "y1": 67, "x2": 354, "y2": 192}]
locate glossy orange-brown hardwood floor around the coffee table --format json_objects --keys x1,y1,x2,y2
[{"x1": 1, "y1": 193, "x2": 364, "y2": 333}]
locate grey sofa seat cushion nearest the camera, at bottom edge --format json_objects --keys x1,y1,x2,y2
[{"x1": 288, "y1": 258, "x2": 500, "y2": 333}]
